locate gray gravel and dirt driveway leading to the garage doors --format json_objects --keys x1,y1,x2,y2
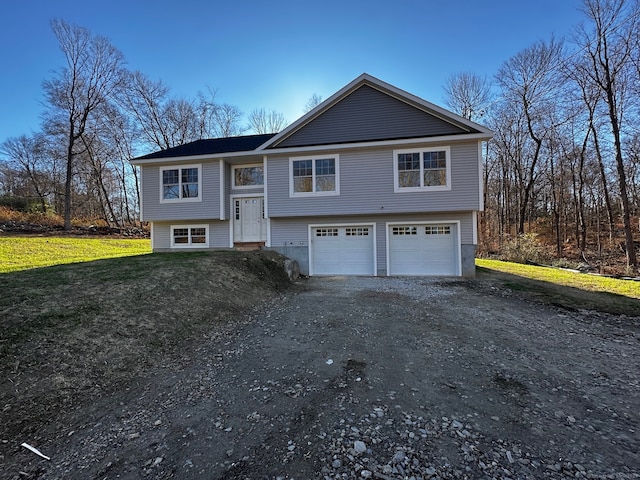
[{"x1": 0, "y1": 264, "x2": 640, "y2": 480}]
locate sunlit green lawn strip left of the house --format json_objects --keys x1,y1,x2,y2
[{"x1": 0, "y1": 236, "x2": 151, "y2": 273}]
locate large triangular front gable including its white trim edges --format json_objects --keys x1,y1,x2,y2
[{"x1": 261, "y1": 74, "x2": 491, "y2": 148}]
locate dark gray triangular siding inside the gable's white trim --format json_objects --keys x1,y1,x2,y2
[{"x1": 272, "y1": 85, "x2": 468, "y2": 148}]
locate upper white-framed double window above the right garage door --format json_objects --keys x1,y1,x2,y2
[{"x1": 393, "y1": 147, "x2": 451, "y2": 192}]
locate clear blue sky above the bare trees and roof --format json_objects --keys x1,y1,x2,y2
[{"x1": 0, "y1": 0, "x2": 582, "y2": 142}]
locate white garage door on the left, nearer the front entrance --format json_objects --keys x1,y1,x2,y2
[{"x1": 311, "y1": 225, "x2": 375, "y2": 275}]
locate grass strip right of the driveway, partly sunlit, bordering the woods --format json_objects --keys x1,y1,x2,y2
[{"x1": 476, "y1": 259, "x2": 640, "y2": 316}]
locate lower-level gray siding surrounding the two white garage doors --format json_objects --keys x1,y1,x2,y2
[{"x1": 271, "y1": 212, "x2": 475, "y2": 275}]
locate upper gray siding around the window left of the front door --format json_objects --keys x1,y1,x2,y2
[{"x1": 141, "y1": 160, "x2": 220, "y2": 222}]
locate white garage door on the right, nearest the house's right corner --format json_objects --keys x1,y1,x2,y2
[{"x1": 389, "y1": 223, "x2": 459, "y2": 275}]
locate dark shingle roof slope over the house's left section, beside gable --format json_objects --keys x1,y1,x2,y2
[{"x1": 135, "y1": 133, "x2": 275, "y2": 160}]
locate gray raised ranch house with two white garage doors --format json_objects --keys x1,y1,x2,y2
[{"x1": 132, "y1": 74, "x2": 492, "y2": 276}]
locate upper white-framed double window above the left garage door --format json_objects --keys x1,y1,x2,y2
[{"x1": 289, "y1": 155, "x2": 340, "y2": 197}]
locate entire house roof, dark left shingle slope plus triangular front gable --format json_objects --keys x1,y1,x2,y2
[{"x1": 132, "y1": 73, "x2": 493, "y2": 164}]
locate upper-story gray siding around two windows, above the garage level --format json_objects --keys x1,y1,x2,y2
[{"x1": 267, "y1": 141, "x2": 480, "y2": 218}]
